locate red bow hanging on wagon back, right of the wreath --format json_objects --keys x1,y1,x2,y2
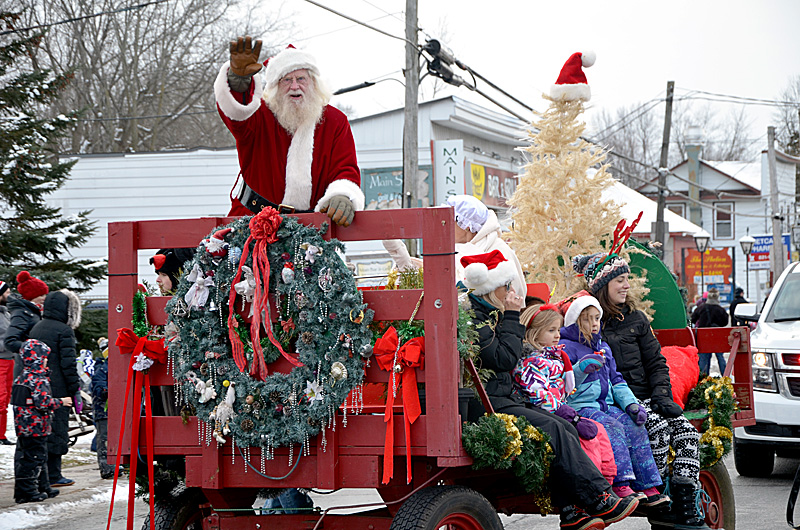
[{"x1": 372, "y1": 326, "x2": 425, "y2": 484}]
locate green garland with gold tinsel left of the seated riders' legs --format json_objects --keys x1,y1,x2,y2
[{"x1": 461, "y1": 414, "x2": 553, "y2": 514}]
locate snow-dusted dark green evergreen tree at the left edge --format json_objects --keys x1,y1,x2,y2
[{"x1": 0, "y1": 12, "x2": 106, "y2": 291}]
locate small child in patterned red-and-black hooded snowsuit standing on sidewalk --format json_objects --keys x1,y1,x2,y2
[{"x1": 11, "y1": 339, "x2": 72, "y2": 504}]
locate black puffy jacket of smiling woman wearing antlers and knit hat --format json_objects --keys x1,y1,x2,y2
[{"x1": 602, "y1": 308, "x2": 672, "y2": 400}]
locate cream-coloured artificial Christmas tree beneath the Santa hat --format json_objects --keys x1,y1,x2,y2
[{"x1": 509, "y1": 96, "x2": 621, "y2": 300}]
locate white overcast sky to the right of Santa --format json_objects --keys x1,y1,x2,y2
[{"x1": 270, "y1": 0, "x2": 800, "y2": 145}]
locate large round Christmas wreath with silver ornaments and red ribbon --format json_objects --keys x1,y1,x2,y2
[{"x1": 165, "y1": 209, "x2": 373, "y2": 458}]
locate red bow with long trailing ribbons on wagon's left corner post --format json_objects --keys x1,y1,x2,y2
[{"x1": 106, "y1": 328, "x2": 167, "y2": 530}]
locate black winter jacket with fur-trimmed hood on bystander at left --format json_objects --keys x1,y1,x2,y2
[{"x1": 30, "y1": 291, "x2": 81, "y2": 398}]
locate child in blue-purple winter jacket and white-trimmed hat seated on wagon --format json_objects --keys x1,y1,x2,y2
[{"x1": 560, "y1": 293, "x2": 669, "y2": 507}]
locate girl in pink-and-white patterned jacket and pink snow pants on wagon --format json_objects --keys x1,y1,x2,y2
[{"x1": 513, "y1": 304, "x2": 617, "y2": 484}]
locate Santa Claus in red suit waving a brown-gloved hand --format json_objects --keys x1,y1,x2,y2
[{"x1": 214, "y1": 37, "x2": 364, "y2": 226}]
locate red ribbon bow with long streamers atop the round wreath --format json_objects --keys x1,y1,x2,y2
[{"x1": 228, "y1": 208, "x2": 303, "y2": 381}]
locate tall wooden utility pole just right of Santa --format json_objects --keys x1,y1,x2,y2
[{"x1": 402, "y1": 0, "x2": 419, "y2": 256}]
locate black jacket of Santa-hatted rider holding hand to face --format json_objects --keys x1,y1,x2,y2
[{"x1": 469, "y1": 295, "x2": 525, "y2": 409}]
